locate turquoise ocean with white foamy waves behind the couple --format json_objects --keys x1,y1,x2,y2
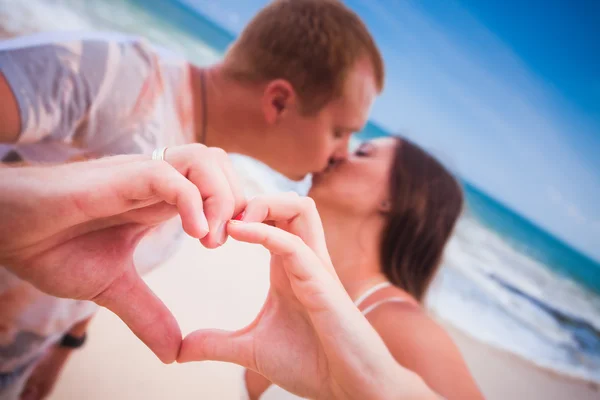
[{"x1": 0, "y1": 0, "x2": 600, "y2": 384}]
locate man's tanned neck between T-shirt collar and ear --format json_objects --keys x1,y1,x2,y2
[{"x1": 191, "y1": 65, "x2": 265, "y2": 158}]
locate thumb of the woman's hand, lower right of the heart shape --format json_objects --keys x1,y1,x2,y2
[{"x1": 177, "y1": 329, "x2": 255, "y2": 369}]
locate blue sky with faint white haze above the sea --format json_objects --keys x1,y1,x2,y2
[{"x1": 186, "y1": 0, "x2": 600, "y2": 260}]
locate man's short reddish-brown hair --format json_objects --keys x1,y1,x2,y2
[{"x1": 224, "y1": 0, "x2": 384, "y2": 114}]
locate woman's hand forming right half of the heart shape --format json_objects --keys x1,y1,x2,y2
[{"x1": 178, "y1": 194, "x2": 433, "y2": 399}]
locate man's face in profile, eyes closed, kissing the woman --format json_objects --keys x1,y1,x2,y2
[{"x1": 274, "y1": 57, "x2": 377, "y2": 180}]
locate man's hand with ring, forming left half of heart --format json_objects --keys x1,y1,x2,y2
[{"x1": 0, "y1": 145, "x2": 246, "y2": 362}]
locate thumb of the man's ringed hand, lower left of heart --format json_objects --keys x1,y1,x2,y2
[{"x1": 93, "y1": 267, "x2": 182, "y2": 364}]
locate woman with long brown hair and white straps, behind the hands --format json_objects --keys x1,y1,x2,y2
[{"x1": 240, "y1": 138, "x2": 481, "y2": 399}]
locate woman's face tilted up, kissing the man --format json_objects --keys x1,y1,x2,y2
[{"x1": 309, "y1": 138, "x2": 400, "y2": 216}]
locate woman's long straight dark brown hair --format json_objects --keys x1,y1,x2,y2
[{"x1": 381, "y1": 138, "x2": 463, "y2": 302}]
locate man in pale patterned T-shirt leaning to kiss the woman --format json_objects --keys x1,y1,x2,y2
[{"x1": 0, "y1": 0, "x2": 384, "y2": 395}]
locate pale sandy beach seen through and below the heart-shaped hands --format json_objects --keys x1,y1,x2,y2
[{"x1": 51, "y1": 234, "x2": 600, "y2": 400}]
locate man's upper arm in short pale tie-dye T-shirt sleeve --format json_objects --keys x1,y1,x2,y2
[{"x1": 0, "y1": 33, "x2": 155, "y2": 148}]
